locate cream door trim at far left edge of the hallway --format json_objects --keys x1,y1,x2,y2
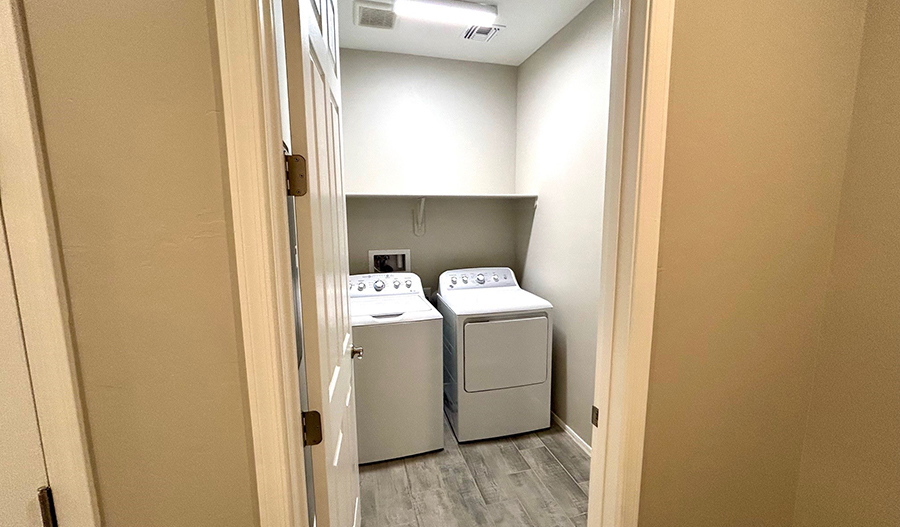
[{"x1": 0, "y1": 0, "x2": 100, "y2": 527}]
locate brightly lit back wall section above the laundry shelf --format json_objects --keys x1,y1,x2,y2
[{"x1": 341, "y1": 49, "x2": 516, "y2": 194}]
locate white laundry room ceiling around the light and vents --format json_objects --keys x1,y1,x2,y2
[{"x1": 338, "y1": 0, "x2": 591, "y2": 66}]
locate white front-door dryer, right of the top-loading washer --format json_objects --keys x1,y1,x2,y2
[{"x1": 437, "y1": 267, "x2": 553, "y2": 441}]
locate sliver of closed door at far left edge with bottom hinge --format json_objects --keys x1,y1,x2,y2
[{"x1": 0, "y1": 204, "x2": 47, "y2": 527}]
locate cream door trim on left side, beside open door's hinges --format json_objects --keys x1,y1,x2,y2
[{"x1": 215, "y1": 0, "x2": 308, "y2": 527}]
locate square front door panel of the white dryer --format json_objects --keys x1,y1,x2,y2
[{"x1": 463, "y1": 316, "x2": 550, "y2": 392}]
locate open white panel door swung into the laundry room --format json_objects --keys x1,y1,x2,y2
[{"x1": 282, "y1": 0, "x2": 360, "y2": 527}]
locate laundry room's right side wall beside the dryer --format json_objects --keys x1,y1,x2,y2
[{"x1": 516, "y1": 0, "x2": 612, "y2": 442}]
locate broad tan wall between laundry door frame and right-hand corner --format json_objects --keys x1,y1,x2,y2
[{"x1": 640, "y1": 0, "x2": 865, "y2": 527}]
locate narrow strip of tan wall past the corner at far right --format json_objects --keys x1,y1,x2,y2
[{"x1": 794, "y1": 0, "x2": 900, "y2": 527}]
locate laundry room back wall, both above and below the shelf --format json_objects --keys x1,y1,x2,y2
[{"x1": 341, "y1": 49, "x2": 530, "y2": 294}]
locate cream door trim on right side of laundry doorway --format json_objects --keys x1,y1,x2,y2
[{"x1": 588, "y1": 0, "x2": 675, "y2": 527}]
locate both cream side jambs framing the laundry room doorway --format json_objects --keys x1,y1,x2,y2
[{"x1": 214, "y1": 0, "x2": 675, "y2": 527}]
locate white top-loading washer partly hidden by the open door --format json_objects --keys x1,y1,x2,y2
[{"x1": 350, "y1": 273, "x2": 444, "y2": 463}]
